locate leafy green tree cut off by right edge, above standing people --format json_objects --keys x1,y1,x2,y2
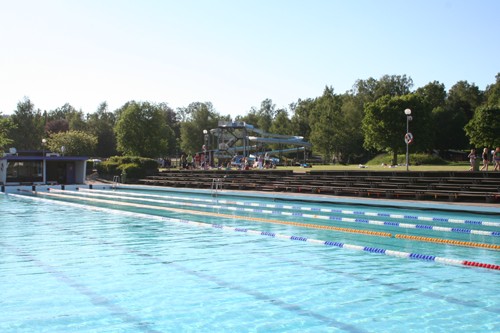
[{"x1": 465, "y1": 105, "x2": 500, "y2": 147}]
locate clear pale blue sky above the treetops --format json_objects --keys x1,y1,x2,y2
[{"x1": 0, "y1": 0, "x2": 500, "y2": 117}]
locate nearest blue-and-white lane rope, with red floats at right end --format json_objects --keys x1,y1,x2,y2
[{"x1": 10, "y1": 192, "x2": 500, "y2": 271}]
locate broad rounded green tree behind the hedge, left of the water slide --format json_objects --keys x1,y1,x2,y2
[{"x1": 115, "y1": 101, "x2": 173, "y2": 158}]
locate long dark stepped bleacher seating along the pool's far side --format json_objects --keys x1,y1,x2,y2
[{"x1": 139, "y1": 169, "x2": 500, "y2": 203}]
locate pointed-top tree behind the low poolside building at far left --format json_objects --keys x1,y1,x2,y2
[{"x1": 9, "y1": 97, "x2": 45, "y2": 150}]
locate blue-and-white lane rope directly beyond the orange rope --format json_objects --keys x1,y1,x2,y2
[{"x1": 68, "y1": 190, "x2": 500, "y2": 237}]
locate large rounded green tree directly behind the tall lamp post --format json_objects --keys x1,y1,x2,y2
[{"x1": 362, "y1": 94, "x2": 432, "y2": 164}]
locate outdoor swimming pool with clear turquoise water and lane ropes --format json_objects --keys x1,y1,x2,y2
[{"x1": 0, "y1": 188, "x2": 500, "y2": 332}]
